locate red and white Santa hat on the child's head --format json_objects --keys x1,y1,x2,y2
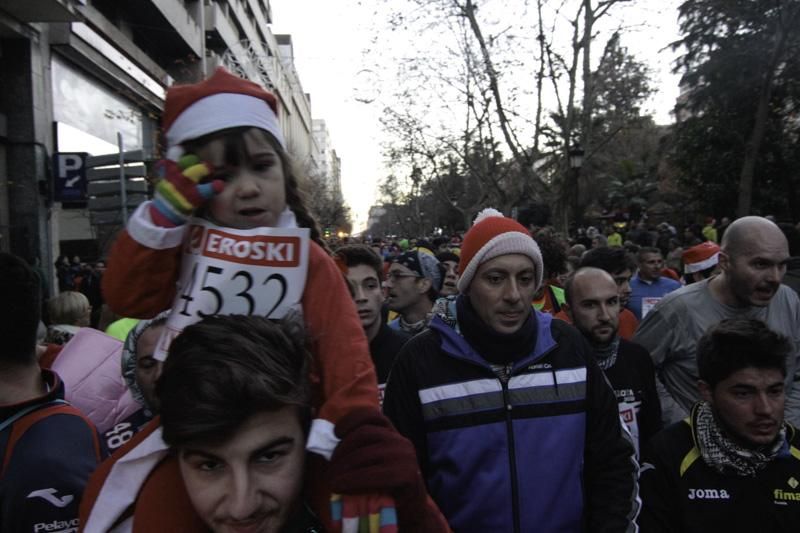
[{"x1": 162, "y1": 67, "x2": 286, "y2": 160}]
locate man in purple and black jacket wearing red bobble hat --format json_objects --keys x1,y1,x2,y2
[{"x1": 384, "y1": 209, "x2": 639, "y2": 532}]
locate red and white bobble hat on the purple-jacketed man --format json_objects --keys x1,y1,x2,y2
[{"x1": 458, "y1": 207, "x2": 543, "y2": 292}]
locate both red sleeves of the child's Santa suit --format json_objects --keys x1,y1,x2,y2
[{"x1": 103, "y1": 224, "x2": 379, "y2": 444}]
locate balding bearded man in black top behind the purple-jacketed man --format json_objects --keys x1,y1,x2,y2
[{"x1": 564, "y1": 267, "x2": 661, "y2": 454}]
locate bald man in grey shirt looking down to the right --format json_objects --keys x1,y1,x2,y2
[{"x1": 633, "y1": 216, "x2": 800, "y2": 425}]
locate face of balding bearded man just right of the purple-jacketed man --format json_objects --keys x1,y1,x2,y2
[{"x1": 569, "y1": 271, "x2": 619, "y2": 346}]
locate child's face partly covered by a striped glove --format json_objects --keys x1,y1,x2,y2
[{"x1": 196, "y1": 129, "x2": 286, "y2": 229}]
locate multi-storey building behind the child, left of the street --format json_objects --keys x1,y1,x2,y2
[{"x1": 0, "y1": 0, "x2": 332, "y2": 285}]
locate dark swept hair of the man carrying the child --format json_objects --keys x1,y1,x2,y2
[{"x1": 156, "y1": 315, "x2": 311, "y2": 447}]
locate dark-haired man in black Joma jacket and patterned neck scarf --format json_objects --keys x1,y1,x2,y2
[{"x1": 640, "y1": 318, "x2": 800, "y2": 533}]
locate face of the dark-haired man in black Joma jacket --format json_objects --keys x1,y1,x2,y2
[{"x1": 700, "y1": 367, "x2": 786, "y2": 447}]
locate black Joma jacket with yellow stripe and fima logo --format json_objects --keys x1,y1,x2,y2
[{"x1": 639, "y1": 406, "x2": 800, "y2": 533}]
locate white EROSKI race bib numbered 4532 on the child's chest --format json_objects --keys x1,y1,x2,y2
[{"x1": 153, "y1": 219, "x2": 309, "y2": 361}]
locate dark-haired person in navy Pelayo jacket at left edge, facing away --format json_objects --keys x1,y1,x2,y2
[{"x1": 0, "y1": 253, "x2": 102, "y2": 533}]
